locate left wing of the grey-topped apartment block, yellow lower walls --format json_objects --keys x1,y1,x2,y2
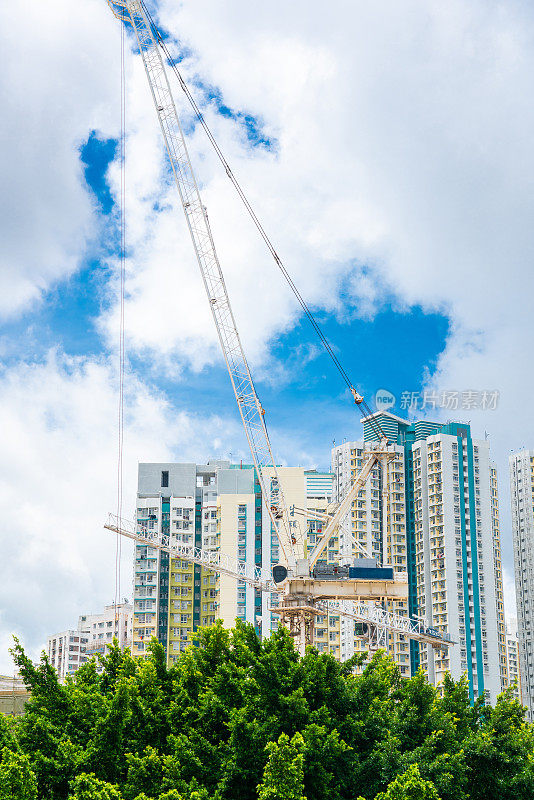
[{"x1": 132, "y1": 462, "x2": 228, "y2": 660}]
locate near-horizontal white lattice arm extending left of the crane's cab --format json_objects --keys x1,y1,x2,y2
[{"x1": 104, "y1": 514, "x2": 278, "y2": 592}]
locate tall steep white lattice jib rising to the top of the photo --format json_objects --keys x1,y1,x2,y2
[{"x1": 108, "y1": 0, "x2": 295, "y2": 566}]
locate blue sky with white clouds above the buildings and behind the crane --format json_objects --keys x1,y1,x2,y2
[{"x1": 0, "y1": 0, "x2": 534, "y2": 672}]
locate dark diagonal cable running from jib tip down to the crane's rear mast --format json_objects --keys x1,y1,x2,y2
[{"x1": 141, "y1": 0, "x2": 387, "y2": 439}]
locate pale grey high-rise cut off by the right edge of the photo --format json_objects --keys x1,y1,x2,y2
[{"x1": 510, "y1": 450, "x2": 534, "y2": 721}]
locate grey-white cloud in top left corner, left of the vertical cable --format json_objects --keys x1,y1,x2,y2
[{"x1": 0, "y1": 0, "x2": 120, "y2": 317}]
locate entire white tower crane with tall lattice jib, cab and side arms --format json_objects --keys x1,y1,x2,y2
[{"x1": 105, "y1": 0, "x2": 451, "y2": 654}]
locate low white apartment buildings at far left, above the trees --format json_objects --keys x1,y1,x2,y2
[{"x1": 46, "y1": 601, "x2": 133, "y2": 681}]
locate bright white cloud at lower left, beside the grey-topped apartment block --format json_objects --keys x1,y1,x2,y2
[{"x1": 0, "y1": 353, "x2": 238, "y2": 672}]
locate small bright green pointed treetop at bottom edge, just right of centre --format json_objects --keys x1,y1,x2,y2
[{"x1": 258, "y1": 733, "x2": 306, "y2": 800}]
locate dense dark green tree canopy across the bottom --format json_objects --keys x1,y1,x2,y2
[{"x1": 0, "y1": 623, "x2": 534, "y2": 800}]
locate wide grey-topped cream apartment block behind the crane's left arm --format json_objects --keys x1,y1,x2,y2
[{"x1": 133, "y1": 461, "x2": 339, "y2": 662}]
